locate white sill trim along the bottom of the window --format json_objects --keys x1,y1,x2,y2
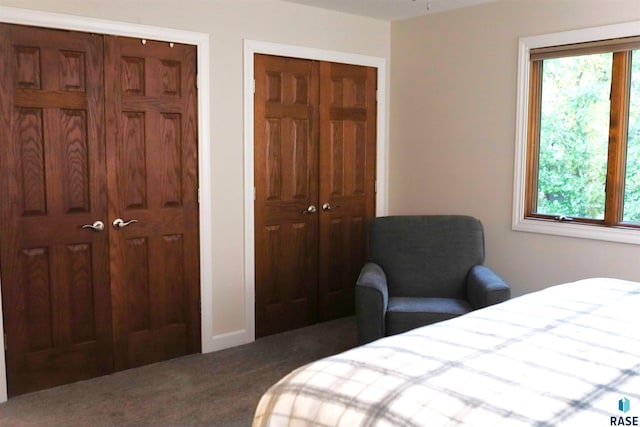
[{"x1": 512, "y1": 219, "x2": 640, "y2": 245}]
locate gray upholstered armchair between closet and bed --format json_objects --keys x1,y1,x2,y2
[{"x1": 356, "y1": 215, "x2": 511, "y2": 344}]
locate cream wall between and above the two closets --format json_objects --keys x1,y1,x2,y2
[{"x1": 0, "y1": 0, "x2": 390, "y2": 336}]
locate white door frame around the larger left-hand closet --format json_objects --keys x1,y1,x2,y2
[{"x1": 0, "y1": 6, "x2": 216, "y2": 402}]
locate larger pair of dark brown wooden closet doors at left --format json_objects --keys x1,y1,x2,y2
[{"x1": 0, "y1": 24, "x2": 200, "y2": 396}]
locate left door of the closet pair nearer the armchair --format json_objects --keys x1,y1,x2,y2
[{"x1": 254, "y1": 55, "x2": 319, "y2": 337}]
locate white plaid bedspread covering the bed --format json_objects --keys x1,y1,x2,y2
[{"x1": 253, "y1": 279, "x2": 640, "y2": 427}]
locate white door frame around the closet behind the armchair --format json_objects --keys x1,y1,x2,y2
[{"x1": 244, "y1": 40, "x2": 388, "y2": 341}]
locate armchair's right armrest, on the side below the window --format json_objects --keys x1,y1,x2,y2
[{"x1": 467, "y1": 265, "x2": 511, "y2": 309}]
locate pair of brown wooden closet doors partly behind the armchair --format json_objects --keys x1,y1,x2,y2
[{"x1": 254, "y1": 55, "x2": 377, "y2": 337}]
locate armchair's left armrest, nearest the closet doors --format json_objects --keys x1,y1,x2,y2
[{"x1": 356, "y1": 262, "x2": 389, "y2": 345}]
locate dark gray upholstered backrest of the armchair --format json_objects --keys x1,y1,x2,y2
[{"x1": 368, "y1": 215, "x2": 484, "y2": 299}]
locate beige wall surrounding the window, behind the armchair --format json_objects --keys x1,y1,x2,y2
[{"x1": 389, "y1": 0, "x2": 640, "y2": 295}]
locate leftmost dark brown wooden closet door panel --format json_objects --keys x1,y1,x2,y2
[{"x1": 0, "y1": 24, "x2": 112, "y2": 396}]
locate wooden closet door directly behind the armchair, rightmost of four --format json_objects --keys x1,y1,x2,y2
[{"x1": 319, "y1": 62, "x2": 377, "y2": 320}]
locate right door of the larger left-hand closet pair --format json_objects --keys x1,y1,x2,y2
[{"x1": 105, "y1": 36, "x2": 200, "y2": 370}]
